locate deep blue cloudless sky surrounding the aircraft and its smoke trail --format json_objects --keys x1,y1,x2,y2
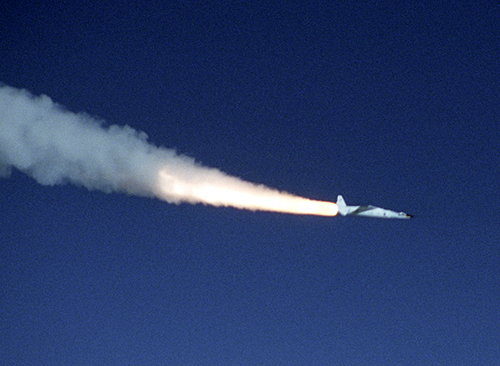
[{"x1": 0, "y1": 1, "x2": 500, "y2": 366}]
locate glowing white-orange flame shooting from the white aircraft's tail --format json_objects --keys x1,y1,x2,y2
[{"x1": 158, "y1": 170, "x2": 339, "y2": 216}]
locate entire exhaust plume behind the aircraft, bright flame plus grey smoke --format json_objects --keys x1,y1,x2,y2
[{"x1": 0, "y1": 85, "x2": 338, "y2": 216}]
